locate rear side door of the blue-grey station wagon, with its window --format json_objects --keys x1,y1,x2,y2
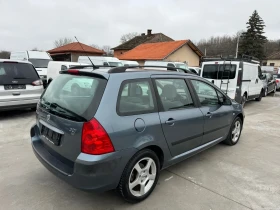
[{"x1": 153, "y1": 77, "x2": 203, "y2": 156}]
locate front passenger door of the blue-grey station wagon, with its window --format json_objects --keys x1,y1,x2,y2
[{"x1": 191, "y1": 80, "x2": 233, "y2": 144}]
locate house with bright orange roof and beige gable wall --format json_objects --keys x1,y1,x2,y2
[{"x1": 119, "y1": 40, "x2": 203, "y2": 66}]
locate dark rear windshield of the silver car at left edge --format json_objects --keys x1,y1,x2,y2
[{"x1": 0, "y1": 62, "x2": 39, "y2": 84}]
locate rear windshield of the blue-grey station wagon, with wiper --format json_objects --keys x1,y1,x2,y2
[{"x1": 40, "y1": 74, "x2": 107, "y2": 121}]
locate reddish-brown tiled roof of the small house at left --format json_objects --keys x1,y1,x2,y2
[{"x1": 48, "y1": 42, "x2": 105, "y2": 55}]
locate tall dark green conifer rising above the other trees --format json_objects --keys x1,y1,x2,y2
[{"x1": 239, "y1": 10, "x2": 267, "y2": 60}]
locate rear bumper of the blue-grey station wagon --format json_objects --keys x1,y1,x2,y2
[{"x1": 30, "y1": 125, "x2": 137, "y2": 192}]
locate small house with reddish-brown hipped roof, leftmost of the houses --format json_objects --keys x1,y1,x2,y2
[{"x1": 48, "y1": 42, "x2": 105, "y2": 62}]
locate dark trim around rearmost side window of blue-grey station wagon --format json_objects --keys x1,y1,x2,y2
[{"x1": 116, "y1": 78, "x2": 158, "y2": 116}]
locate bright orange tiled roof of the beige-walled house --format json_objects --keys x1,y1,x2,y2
[{"x1": 119, "y1": 40, "x2": 203, "y2": 60}]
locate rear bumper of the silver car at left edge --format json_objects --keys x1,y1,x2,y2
[{"x1": 0, "y1": 97, "x2": 39, "y2": 111}]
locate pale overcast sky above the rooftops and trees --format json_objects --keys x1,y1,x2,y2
[{"x1": 0, "y1": 0, "x2": 280, "y2": 51}]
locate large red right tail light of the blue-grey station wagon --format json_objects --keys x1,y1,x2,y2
[{"x1": 81, "y1": 118, "x2": 115, "y2": 155}]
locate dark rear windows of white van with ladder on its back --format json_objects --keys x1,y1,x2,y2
[{"x1": 202, "y1": 64, "x2": 236, "y2": 79}]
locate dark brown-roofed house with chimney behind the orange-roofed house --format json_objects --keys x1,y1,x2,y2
[{"x1": 112, "y1": 29, "x2": 174, "y2": 58}]
